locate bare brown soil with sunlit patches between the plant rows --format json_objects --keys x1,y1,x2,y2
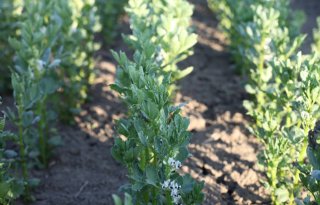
[{"x1": 7, "y1": 0, "x2": 320, "y2": 205}]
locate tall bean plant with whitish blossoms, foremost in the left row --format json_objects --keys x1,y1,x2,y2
[{"x1": 7, "y1": 1, "x2": 62, "y2": 168}]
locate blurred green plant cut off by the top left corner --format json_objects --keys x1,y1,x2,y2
[{"x1": 0, "y1": 0, "x2": 23, "y2": 93}]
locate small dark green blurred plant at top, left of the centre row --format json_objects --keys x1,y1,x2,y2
[{"x1": 96, "y1": 0, "x2": 128, "y2": 44}]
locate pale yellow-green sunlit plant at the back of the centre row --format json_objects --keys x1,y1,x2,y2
[{"x1": 126, "y1": 0, "x2": 197, "y2": 92}]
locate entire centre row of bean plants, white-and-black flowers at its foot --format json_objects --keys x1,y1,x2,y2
[{"x1": 112, "y1": 0, "x2": 204, "y2": 205}]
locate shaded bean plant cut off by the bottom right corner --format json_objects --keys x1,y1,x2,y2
[{"x1": 296, "y1": 123, "x2": 320, "y2": 205}]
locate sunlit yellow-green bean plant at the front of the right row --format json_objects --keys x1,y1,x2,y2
[{"x1": 249, "y1": 55, "x2": 320, "y2": 204}]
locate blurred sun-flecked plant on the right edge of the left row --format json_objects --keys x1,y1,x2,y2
[{"x1": 54, "y1": 0, "x2": 101, "y2": 122}]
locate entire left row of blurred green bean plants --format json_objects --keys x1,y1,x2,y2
[{"x1": 0, "y1": 0, "x2": 125, "y2": 204}]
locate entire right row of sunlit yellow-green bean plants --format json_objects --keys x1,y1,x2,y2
[{"x1": 209, "y1": 0, "x2": 320, "y2": 204}]
